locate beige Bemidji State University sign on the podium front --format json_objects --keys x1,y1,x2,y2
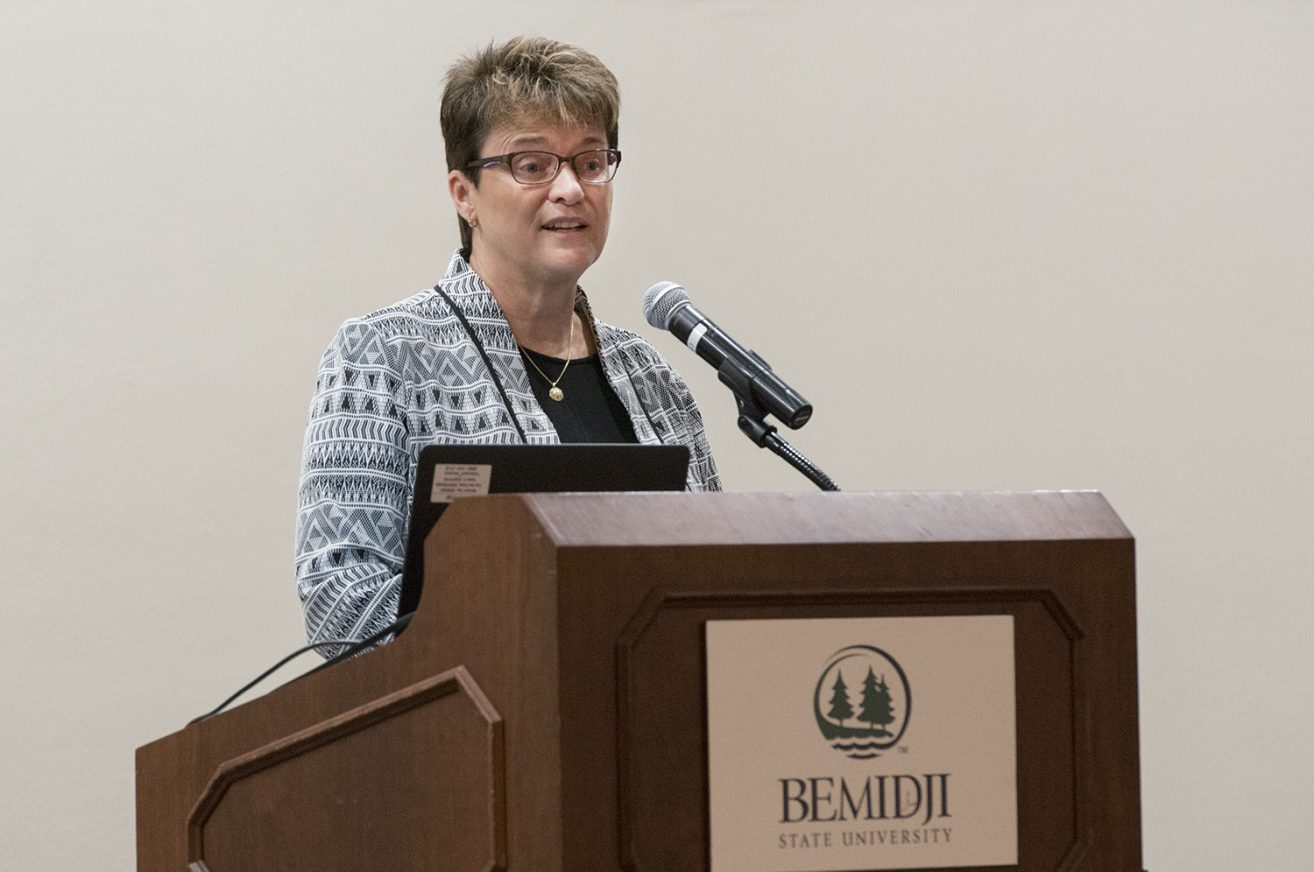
[{"x1": 707, "y1": 615, "x2": 1017, "y2": 872}]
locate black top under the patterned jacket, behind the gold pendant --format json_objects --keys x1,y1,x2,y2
[{"x1": 520, "y1": 348, "x2": 639, "y2": 443}]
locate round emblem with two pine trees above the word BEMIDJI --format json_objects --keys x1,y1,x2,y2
[{"x1": 812, "y1": 645, "x2": 912, "y2": 760}]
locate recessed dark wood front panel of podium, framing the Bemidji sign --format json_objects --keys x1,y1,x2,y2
[{"x1": 618, "y1": 588, "x2": 1091, "y2": 869}]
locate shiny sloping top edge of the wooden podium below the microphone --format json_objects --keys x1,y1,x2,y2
[{"x1": 452, "y1": 491, "x2": 1131, "y2": 548}]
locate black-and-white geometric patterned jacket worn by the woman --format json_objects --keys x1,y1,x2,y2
[{"x1": 296, "y1": 253, "x2": 720, "y2": 651}]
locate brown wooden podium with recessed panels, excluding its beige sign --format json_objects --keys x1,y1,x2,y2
[{"x1": 137, "y1": 492, "x2": 1141, "y2": 872}]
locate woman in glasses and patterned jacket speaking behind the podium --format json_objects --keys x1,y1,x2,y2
[{"x1": 296, "y1": 38, "x2": 720, "y2": 651}]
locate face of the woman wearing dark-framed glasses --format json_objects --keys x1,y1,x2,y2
[{"x1": 448, "y1": 125, "x2": 611, "y2": 288}]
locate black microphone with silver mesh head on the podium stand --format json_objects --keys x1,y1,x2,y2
[{"x1": 644, "y1": 281, "x2": 812, "y2": 429}]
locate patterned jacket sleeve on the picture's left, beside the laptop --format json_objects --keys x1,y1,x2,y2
[{"x1": 296, "y1": 320, "x2": 413, "y2": 657}]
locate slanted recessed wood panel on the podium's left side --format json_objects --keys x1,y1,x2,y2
[{"x1": 180, "y1": 668, "x2": 496, "y2": 872}]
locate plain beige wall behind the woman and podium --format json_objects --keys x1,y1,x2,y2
[{"x1": 0, "y1": 0, "x2": 1314, "y2": 872}]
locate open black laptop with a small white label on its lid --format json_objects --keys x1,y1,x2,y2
[{"x1": 397, "y1": 444, "x2": 689, "y2": 615}]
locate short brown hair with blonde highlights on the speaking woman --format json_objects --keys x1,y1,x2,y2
[{"x1": 439, "y1": 37, "x2": 620, "y2": 257}]
